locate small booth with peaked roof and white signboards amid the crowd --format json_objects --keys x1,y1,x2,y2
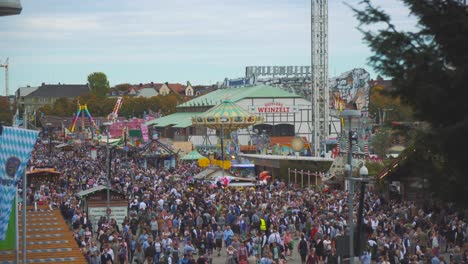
[{"x1": 76, "y1": 185, "x2": 128, "y2": 230}]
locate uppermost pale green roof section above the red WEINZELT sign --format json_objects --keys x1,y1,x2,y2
[{"x1": 177, "y1": 85, "x2": 302, "y2": 108}]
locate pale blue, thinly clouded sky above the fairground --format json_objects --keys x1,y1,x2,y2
[{"x1": 0, "y1": 0, "x2": 415, "y2": 94}]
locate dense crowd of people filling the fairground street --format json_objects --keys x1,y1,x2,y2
[{"x1": 24, "y1": 139, "x2": 468, "y2": 264}]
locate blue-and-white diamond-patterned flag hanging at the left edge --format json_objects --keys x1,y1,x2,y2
[{"x1": 0, "y1": 127, "x2": 39, "y2": 241}]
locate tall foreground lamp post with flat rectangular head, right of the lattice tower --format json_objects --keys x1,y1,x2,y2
[{"x1": 340, "y1": 110, "x2": 361, "y2": 264}]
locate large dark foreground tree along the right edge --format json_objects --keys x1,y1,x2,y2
[{"x1": 353, "y1": 0, "x2": 468, "y2": 206}]
